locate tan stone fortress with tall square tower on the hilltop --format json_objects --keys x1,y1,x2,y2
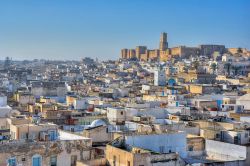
[{"x1": 121, "y1": 32, "x2": 227, "y2": 61}]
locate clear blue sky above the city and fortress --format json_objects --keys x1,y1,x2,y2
[{"x1": 0, "y1": 0, "x2": 250, "y2": 60}]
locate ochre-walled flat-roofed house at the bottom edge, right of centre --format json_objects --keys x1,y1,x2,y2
[{"x1": 106, "y1": 137, "x2": 185, "y2": 166}]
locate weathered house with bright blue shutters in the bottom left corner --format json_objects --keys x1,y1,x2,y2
[{"x1": 0, "y1": 131, "x2": 94, "y2": 166}]
